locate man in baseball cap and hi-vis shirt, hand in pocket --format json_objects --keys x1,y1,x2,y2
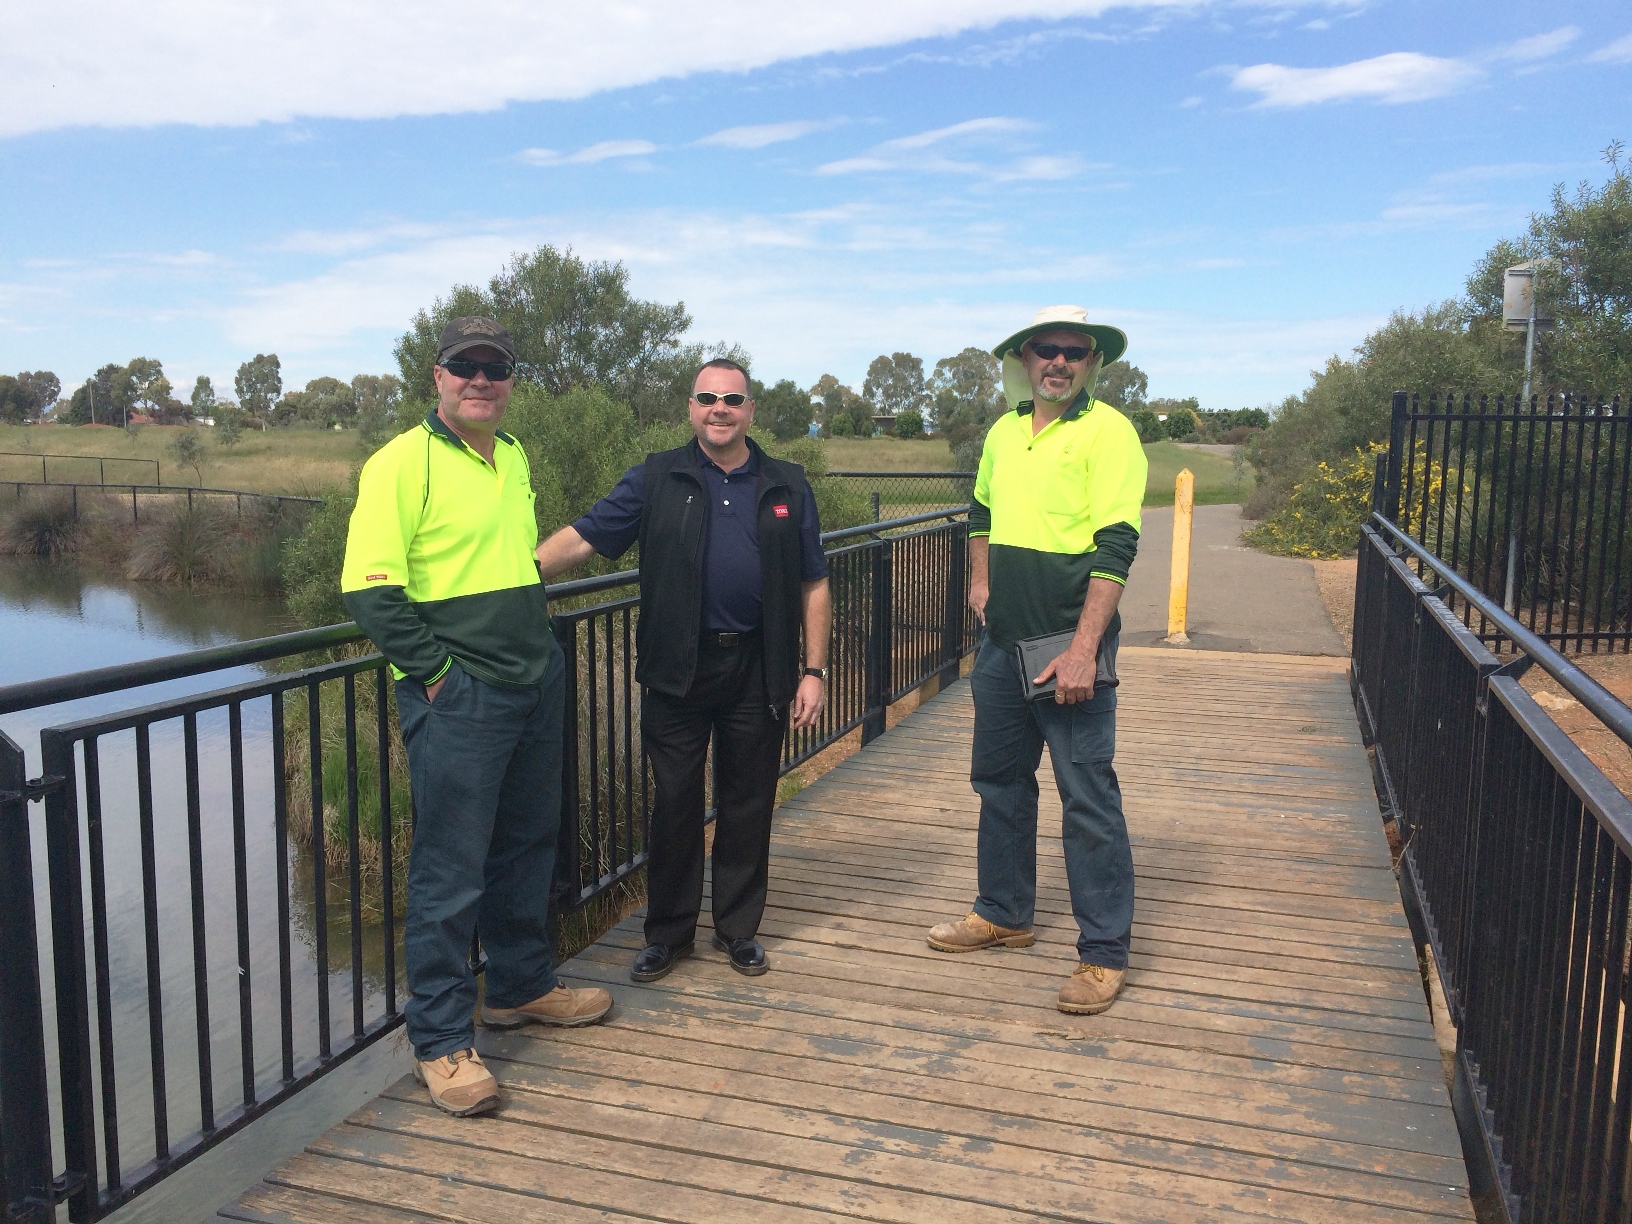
[{"x1": 339, "y1": 317, "x2": 612, "y2": 1116}]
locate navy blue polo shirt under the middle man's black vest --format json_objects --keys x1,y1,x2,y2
[{"x1": 573, "y1": 450, "x2": 827, "y2": 633}]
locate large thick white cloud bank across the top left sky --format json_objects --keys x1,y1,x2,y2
[{"x1": 0, "y1": 0, "x2": 1333, "y2": 137}]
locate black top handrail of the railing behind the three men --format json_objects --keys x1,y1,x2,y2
[{"x1": 0, "y1": 506, "x2": 968, "y2": 715}]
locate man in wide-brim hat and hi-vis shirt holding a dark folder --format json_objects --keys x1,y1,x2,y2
[{"x1": 929, "y1": 307, "x2": 1146, "y2": 1015}]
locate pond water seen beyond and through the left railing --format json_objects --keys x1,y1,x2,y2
[{"x1": 0, "y1": 557, "x2": 401, "y2": 1201}]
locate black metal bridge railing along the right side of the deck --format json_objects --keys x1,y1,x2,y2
[{"x1": 1351, "y1": 509, "x2": 1632, "y2": 1222}]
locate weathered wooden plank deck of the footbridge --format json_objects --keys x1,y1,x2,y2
[{"x1": 219, "y1": 650, "x2": 1472, "y2": 1224}]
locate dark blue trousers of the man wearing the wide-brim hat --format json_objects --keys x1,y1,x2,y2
[{"x1": 969, "y1": 640, "x2": 1133, "y2": 969}]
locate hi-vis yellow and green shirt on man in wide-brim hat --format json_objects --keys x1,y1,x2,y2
[{"x1": 969, "y1": 392, "x2": 1147, "y2": 650}]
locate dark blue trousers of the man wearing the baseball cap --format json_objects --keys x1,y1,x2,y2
[{"x1": 397, "y1": 643, "x2": 566, "y2": 1061}]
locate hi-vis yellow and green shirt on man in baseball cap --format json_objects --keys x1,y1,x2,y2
[{"x1": 339, "y1": 413, "x2": 553, "y2": 689}]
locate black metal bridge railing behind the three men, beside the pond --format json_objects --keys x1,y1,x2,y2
[{"x1": 0, "y1": 512, "x2": 976, "y2": 1221}]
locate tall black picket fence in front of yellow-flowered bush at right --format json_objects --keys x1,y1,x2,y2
[{"x1": 1377, "y1": 392, "x2": 1632, "y2": 653}]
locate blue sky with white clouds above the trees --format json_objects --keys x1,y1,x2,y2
[{"x1": 0, "y1": 0, "x2": 1632, "y2": 408}]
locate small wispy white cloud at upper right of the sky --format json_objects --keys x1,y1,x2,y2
[{"x1": 1231, "y1": 26, "x2": 1581, "y2": 109}]
